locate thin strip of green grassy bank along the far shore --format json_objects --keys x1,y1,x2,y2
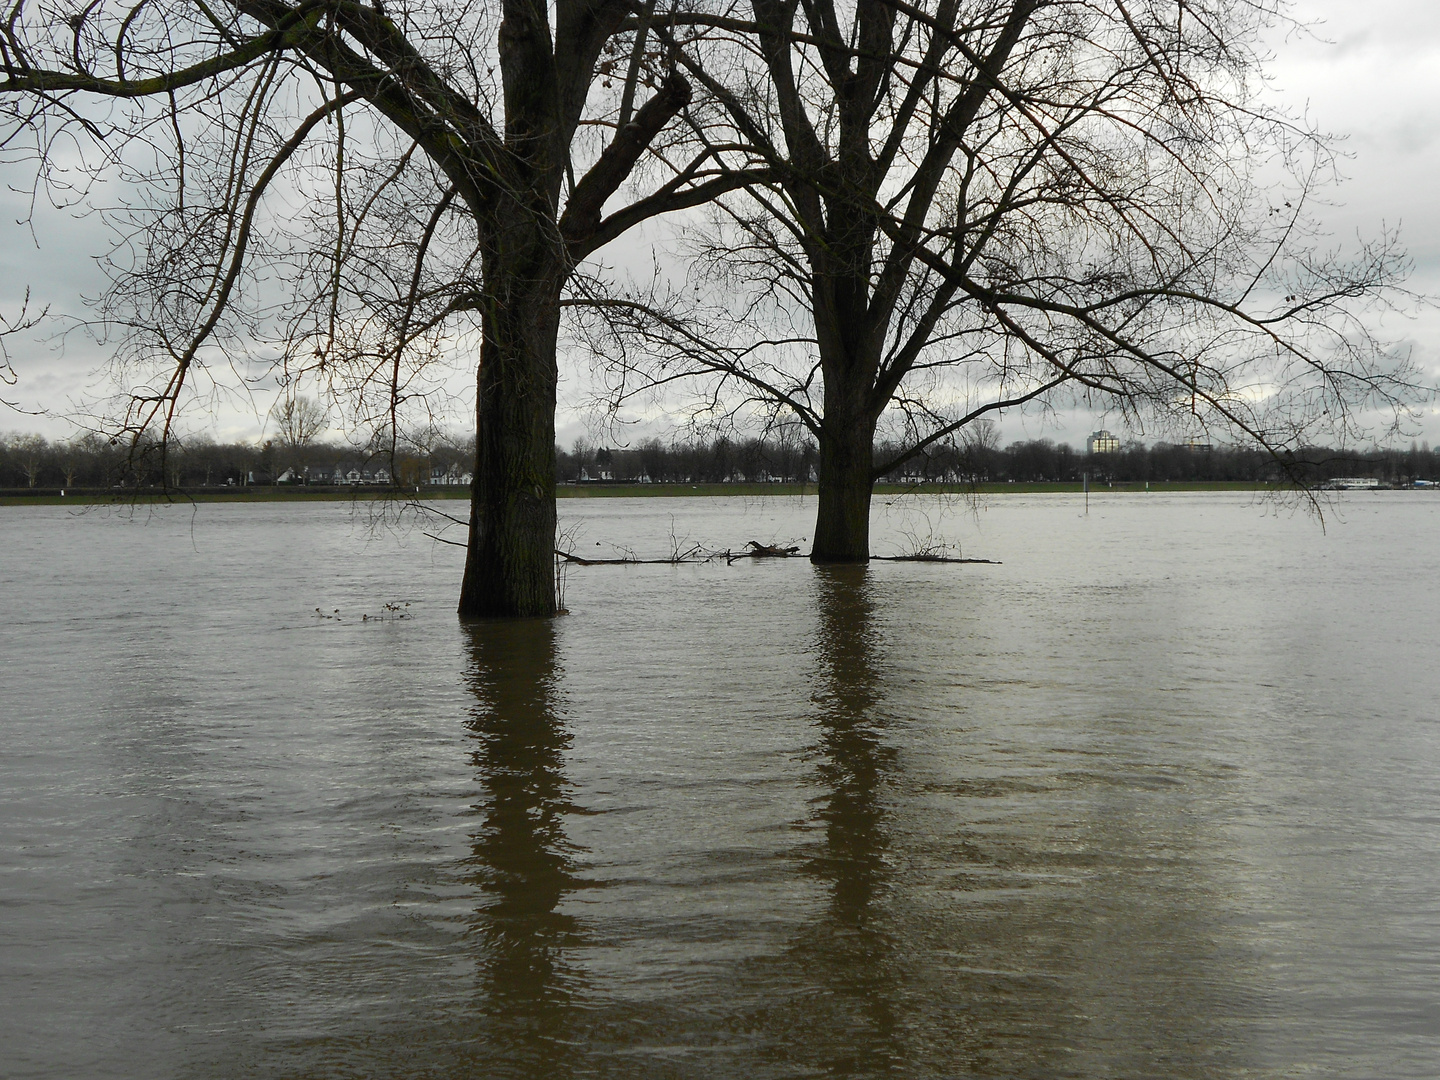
[{"x1": 8, "y1": 481, "x2": 1274, "y2": 507}]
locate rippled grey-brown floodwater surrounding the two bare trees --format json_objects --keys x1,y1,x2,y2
[{"x1": 0, "y1": 492, "x2": 1440, "y2": 1080}]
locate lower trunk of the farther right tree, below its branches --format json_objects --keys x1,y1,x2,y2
[{"x1": 811, "y1": 408, "x2": 876, "y2": 563}]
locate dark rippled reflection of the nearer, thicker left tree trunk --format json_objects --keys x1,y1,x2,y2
[{"x1": 467, "y1": 619, "x2": 586, "y2": 1077}]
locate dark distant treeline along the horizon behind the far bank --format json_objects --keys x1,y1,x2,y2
[{"x1": 0, "y1": 433, "x2": 1440, "y2": 488}]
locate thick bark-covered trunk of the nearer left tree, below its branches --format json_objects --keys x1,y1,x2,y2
[{"x1": 459, "y1": 240, "x2": 564, "y2": 619}]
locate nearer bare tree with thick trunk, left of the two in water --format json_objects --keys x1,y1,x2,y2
[{"x1": 0, "y1": 0, "x2": 753, "y2": 616}]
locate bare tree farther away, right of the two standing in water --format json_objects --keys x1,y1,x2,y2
[{"x1": 598, "y1": 0, "x2": 1417, "y2": 562}]
